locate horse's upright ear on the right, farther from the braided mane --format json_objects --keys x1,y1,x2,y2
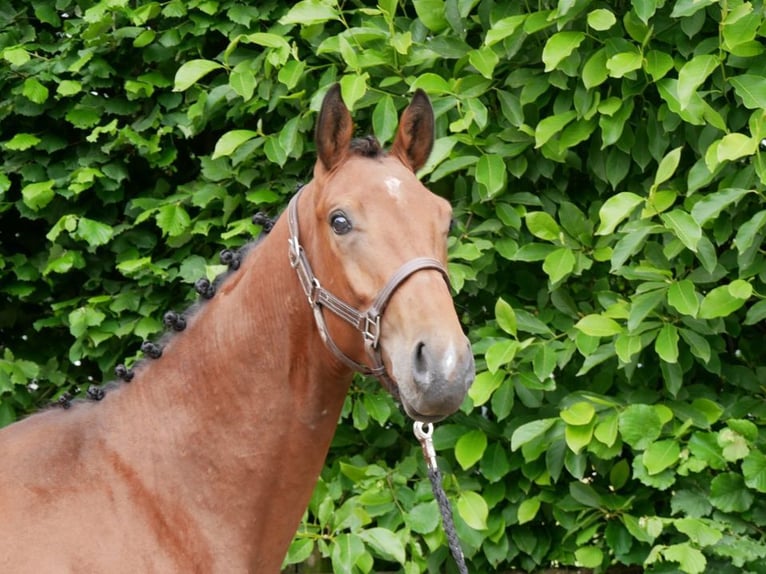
[{"x1": 391, "y1": 89, "x2": 434, "y2": 171}]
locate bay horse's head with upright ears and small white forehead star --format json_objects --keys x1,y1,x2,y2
[{"x1": 294, "y1": 85, "x2": 475, "y2": 422}]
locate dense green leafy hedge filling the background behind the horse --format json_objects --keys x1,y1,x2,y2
[{"x1": 0, "y1": 0, "x2": 766, "y2": 574}]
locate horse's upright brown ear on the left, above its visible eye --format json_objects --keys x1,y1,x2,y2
[{"x1": 314, "y1": 84, "x2": 354, "y2": 171}]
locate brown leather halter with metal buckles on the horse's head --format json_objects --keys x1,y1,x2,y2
[{"x1": 287, "y1": 190, "x2": 449, "y2": 396}]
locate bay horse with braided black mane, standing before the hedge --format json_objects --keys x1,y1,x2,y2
[{"x1": 0, "y1": 86, "x2": 474, "y2": 574}]
